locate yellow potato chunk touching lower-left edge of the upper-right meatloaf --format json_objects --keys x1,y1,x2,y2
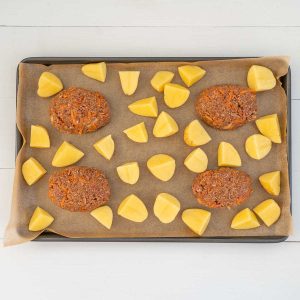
[{"x1": 183, "y1": 120, "x2": 211, "y2": 146}]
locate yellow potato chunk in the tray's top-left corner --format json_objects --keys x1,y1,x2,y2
[{"x1": 37, "y1": 72, "x2": 64, "y2": 98}]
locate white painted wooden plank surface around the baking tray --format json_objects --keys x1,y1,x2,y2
[{"x1": 0, "y1": 0, "x2": 300, "y2": 299}]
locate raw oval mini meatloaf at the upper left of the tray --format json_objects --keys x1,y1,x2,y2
[{"x1": 50, "y1": 87, "x2": 110, "y2": 134}]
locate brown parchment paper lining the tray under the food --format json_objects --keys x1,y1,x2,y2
[{"x1": 4, "y1": 57, "x2": 291, "y2": 245}]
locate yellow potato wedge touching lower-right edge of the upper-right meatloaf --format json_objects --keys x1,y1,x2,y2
[{"x1": 255, "y1": 114, "x2": 281, "y2": 144}]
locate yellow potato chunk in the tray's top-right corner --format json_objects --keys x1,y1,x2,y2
[{"x1": 247, "y1": 65, "x2": 276, "y2": 92}]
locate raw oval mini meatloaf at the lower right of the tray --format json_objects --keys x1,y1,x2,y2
[{"x1": 192, "y1": 168, "x2": 252, "y2": 208}]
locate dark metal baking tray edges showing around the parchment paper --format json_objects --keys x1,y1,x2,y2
[{"x1": 16, "y1": 57, "x2": 292, "y2": 243}]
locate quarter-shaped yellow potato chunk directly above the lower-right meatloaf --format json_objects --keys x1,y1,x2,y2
[{"x1": 218, "y1": 142, "x2": 242, "y2": 167}]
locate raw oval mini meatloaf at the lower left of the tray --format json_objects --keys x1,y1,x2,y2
[{"x1": 48, "y1": 167, "x2": 110, "y2": 212}]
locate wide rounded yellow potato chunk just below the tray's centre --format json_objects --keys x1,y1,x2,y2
[{"x1": 147, "y1": 154, "x2": 176, "y2": 181}]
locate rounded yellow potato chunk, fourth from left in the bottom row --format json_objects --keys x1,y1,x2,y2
[{"x1": 153, "y1": 193, "x2": 180, "y2": 224}]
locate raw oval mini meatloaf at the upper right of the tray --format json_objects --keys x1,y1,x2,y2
[{"x1": 195, "y1": 85, "x2": 257, "y2": 130}]
